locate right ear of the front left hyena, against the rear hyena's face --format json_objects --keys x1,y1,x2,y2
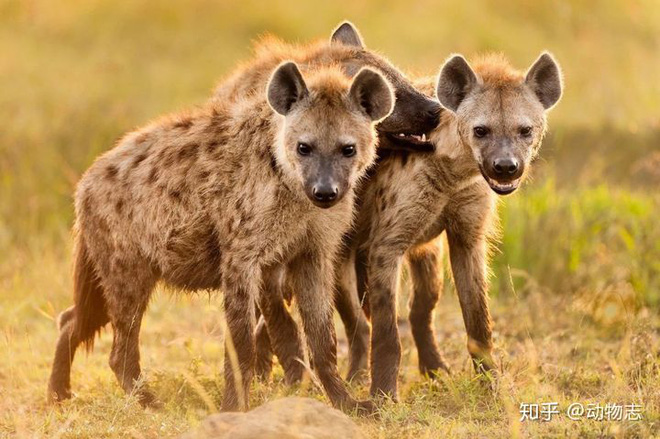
[{"x1": 348, "y1": 68, "x2": 394, "y2": 121}]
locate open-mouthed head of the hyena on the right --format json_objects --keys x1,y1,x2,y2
[{"x1": 437, "y1": 53, "x2": 562, "y2": 195}]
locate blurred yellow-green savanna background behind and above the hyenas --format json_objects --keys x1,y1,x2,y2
[{"x1": 0, "y1": 0, "x2": 660, "y2": 307}]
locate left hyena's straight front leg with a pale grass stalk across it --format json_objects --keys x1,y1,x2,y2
[{"x1": 222, "y1": 269, "x2": 255, "y2": 411}]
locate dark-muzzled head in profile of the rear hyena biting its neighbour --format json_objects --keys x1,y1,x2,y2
[{"x1": 330, "y1": 21, "x2": 441, "y2": 151}]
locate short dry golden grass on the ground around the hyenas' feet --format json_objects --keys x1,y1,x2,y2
[{"x1": 0, "y1": 242, "x2": 660, "y2": 438}]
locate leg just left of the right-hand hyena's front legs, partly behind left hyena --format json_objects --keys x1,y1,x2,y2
[{"x1": 335, "y1": 255, "x2": 371, "y2": 381}]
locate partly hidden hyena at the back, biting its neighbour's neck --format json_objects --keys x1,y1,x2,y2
[{"x1": 213, "y1": 22, "x2": 441, "y2": 382}]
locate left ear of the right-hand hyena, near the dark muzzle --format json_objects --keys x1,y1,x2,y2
[{"x1": 436, "y1": 55, "x2": 478, "y2": 112}]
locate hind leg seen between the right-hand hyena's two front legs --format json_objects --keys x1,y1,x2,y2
[{"x1": 408, "y1": 242, "x2": 449, "y2": 376}]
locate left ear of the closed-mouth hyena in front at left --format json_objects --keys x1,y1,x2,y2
[{"x1": 266, "y1": 61, "x2": 309, "y2": 116}]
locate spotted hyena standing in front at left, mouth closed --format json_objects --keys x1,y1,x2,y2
[{"x1": 49, "y1": 62, "x2": 394, "y2": 410}]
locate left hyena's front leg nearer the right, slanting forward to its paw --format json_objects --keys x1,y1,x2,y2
[{"x1": 288, "y1": 251, "x2": 374, "y2": 413}]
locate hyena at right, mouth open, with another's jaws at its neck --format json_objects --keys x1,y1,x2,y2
[{"x1": 261, "y1": 53, "x2": 562, "y2": 398}]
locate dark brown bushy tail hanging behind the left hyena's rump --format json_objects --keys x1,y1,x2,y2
[{"x1": 70, "y1": 236, "x2": 109, "y2": 351}]
